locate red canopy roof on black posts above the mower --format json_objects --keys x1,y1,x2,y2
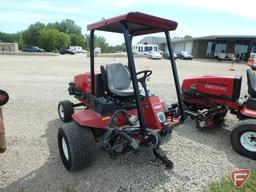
[{"x1": 87, "y1": 12, "x2": 178, "y2": 36}]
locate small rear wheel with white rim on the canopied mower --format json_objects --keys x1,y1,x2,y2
[{"x1": 58, "y1": 100, "x2": 74, "y2": 122}]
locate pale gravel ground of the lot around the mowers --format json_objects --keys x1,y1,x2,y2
[{"x1": 0, "y1": 54, "x2": 256, "y2": 192}]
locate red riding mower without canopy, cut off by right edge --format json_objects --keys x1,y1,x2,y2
[{"x1": 182, "y1": 68, "x2": 256, "y2": 159}]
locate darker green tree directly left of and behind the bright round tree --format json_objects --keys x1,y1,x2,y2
[{"x1": 22, "y1": 22, "x2": 45, "y2": 46}]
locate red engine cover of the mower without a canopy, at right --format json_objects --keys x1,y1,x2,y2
[{"x1": 181, "y1": 75, "x2": 242, "y2": 102}]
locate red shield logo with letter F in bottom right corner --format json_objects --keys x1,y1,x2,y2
[{"x1": 230, "y1": 169, "x2": 251, "y2": 189}]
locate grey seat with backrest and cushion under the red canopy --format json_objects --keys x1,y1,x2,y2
[{"x1": 106, "y1": 63, "x2": 134, "y2": 97}]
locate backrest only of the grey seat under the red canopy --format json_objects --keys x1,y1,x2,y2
[{"x1": 106, "y1": 63, "x2": 131, "y2": 90}]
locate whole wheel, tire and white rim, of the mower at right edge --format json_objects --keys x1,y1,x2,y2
[{"x1": 231, "y1": 119, "x2": 256, "y2": 160}]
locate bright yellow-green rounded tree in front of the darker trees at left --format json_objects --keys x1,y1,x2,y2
[{"x1": 38, "y1": 28, "x2": 60, "y2": 51}]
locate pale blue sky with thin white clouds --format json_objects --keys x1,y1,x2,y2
[{"x1": 0, "y1": 0, "x2": 256, "y2": 45}]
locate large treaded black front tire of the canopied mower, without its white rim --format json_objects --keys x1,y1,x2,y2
[{"x1": 58, "y1": 122, "x2": 95, "y2": 171}]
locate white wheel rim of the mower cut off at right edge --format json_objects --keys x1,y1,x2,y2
[{"x1": 240, "y1": 131, "x2": 256, "y2": 152}]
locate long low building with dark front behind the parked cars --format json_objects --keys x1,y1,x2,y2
[{"x1": 138, "y1": 35, "x2": 256, "y2": 60}]
